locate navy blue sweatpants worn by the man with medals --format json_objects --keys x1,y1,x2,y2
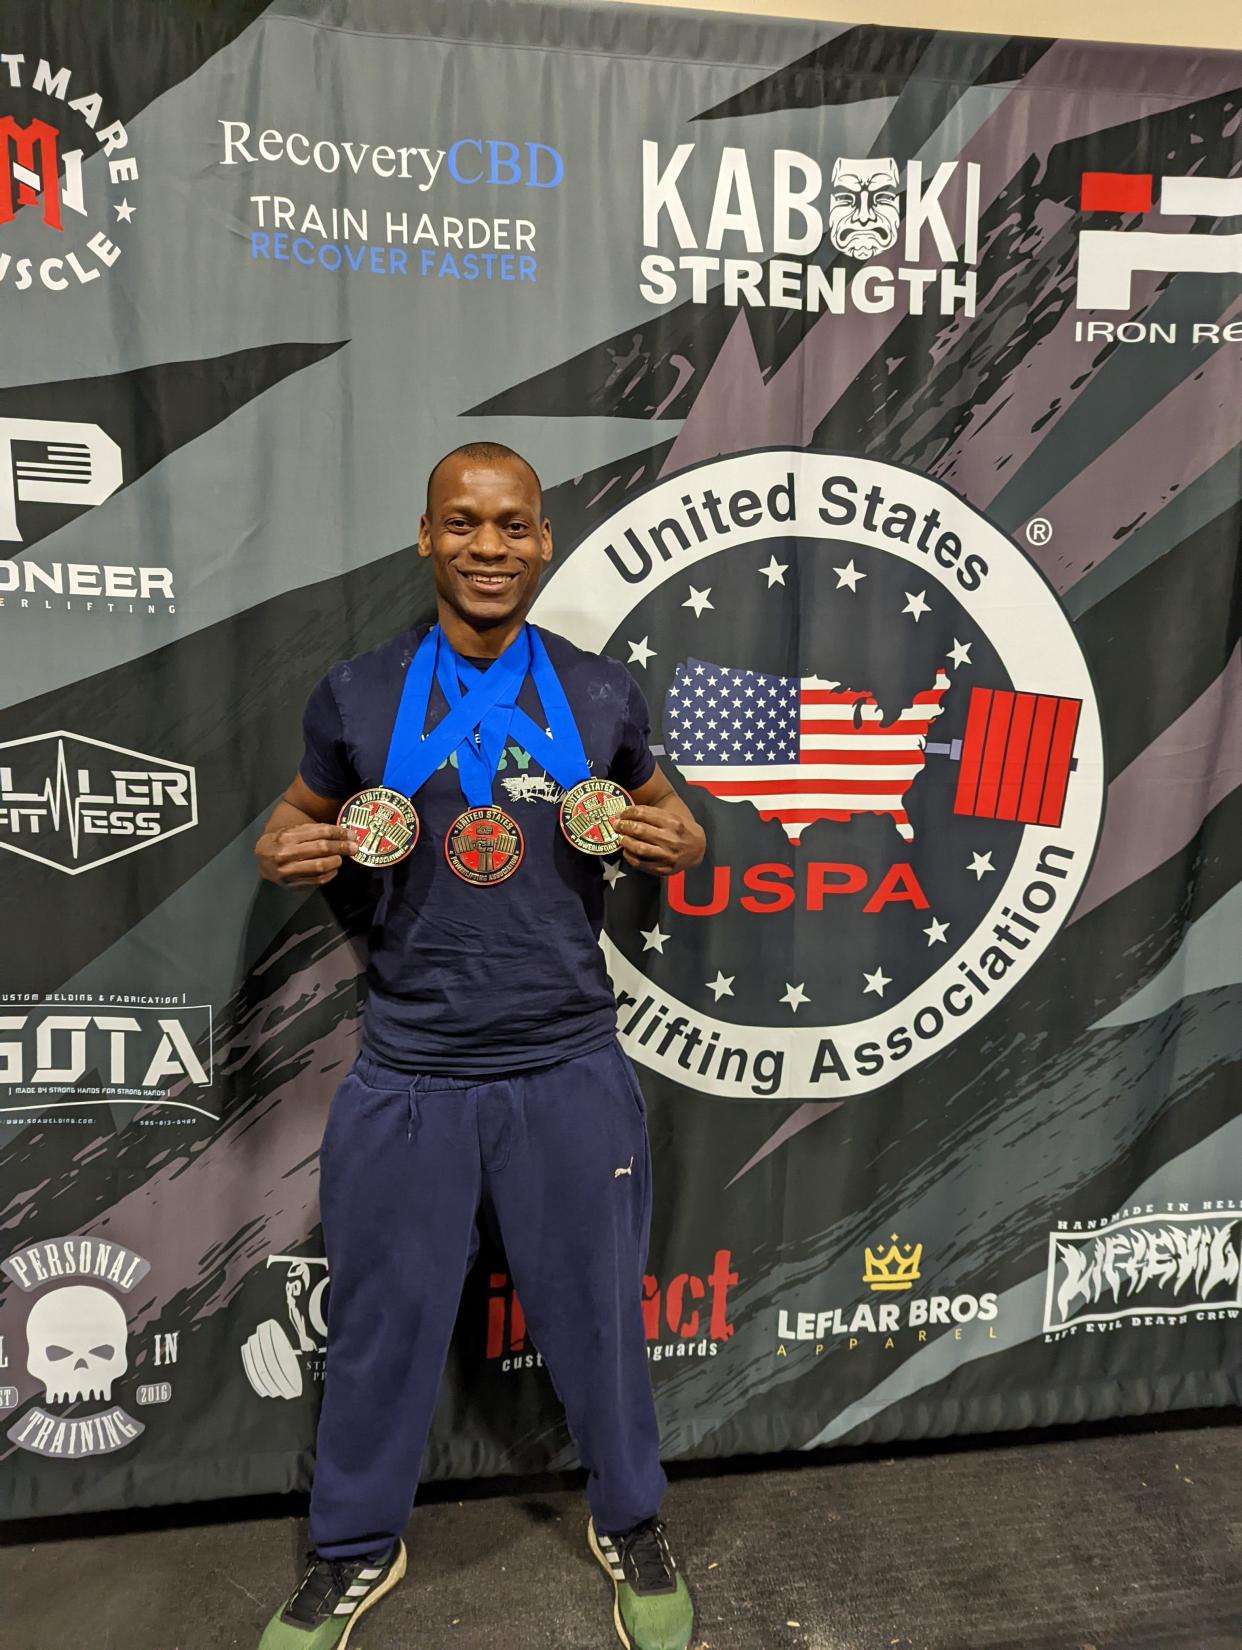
[{"x1": 310, "y1": 1041, "x2": 665, "y2": 1558}]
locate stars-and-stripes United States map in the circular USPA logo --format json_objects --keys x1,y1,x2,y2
[{"x1": 665, "y1": 658, "x2": 950, "y2": 843}]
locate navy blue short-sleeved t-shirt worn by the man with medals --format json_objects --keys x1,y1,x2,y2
[{"x1": 302, "y1": 625, "x2": 655, "y2": 1077}]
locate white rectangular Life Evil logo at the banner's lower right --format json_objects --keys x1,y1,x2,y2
[{"x1": 1044, "y1": 1205, "x2": 1242, "y2": 1338}]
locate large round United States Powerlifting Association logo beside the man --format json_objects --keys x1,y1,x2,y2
[{"x1": 533, "y1": 449, "x2": 1103, "y2": 1101}]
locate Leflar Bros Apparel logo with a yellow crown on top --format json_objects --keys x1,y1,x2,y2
[{"x1": 777, "y1": 1233, "x2": 998, "y2": 1358}]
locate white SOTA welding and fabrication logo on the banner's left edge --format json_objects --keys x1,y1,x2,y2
[{"x1": 0, "y1": 997, "x2": 218, "y2": 1120}]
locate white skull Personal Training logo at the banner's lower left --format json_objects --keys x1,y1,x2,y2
[{"x1": 0, "y1": 1238, "x2": 178, "y2": 1460}]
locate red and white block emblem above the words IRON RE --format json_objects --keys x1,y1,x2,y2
[{"x1": 1077, "y1": 172, "x2": 1242, "y2": 310}]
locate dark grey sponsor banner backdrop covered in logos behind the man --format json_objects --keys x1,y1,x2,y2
[{"x1": 0, "y1": 0, "x2": 1242, "y2": 1515}]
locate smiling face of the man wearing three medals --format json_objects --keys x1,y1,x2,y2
[{"x1": 419, "y1": 457, "x2": 553, "y2": 629}]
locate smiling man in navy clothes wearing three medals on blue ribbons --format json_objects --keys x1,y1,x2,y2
[{"x1": 256, "y1": 442, "x2": 704, "y2": 1650}]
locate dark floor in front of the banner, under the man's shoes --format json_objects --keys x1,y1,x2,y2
[{"x1": 0, "y1": 1414, "x2": 1242, "y2": 1650}]
